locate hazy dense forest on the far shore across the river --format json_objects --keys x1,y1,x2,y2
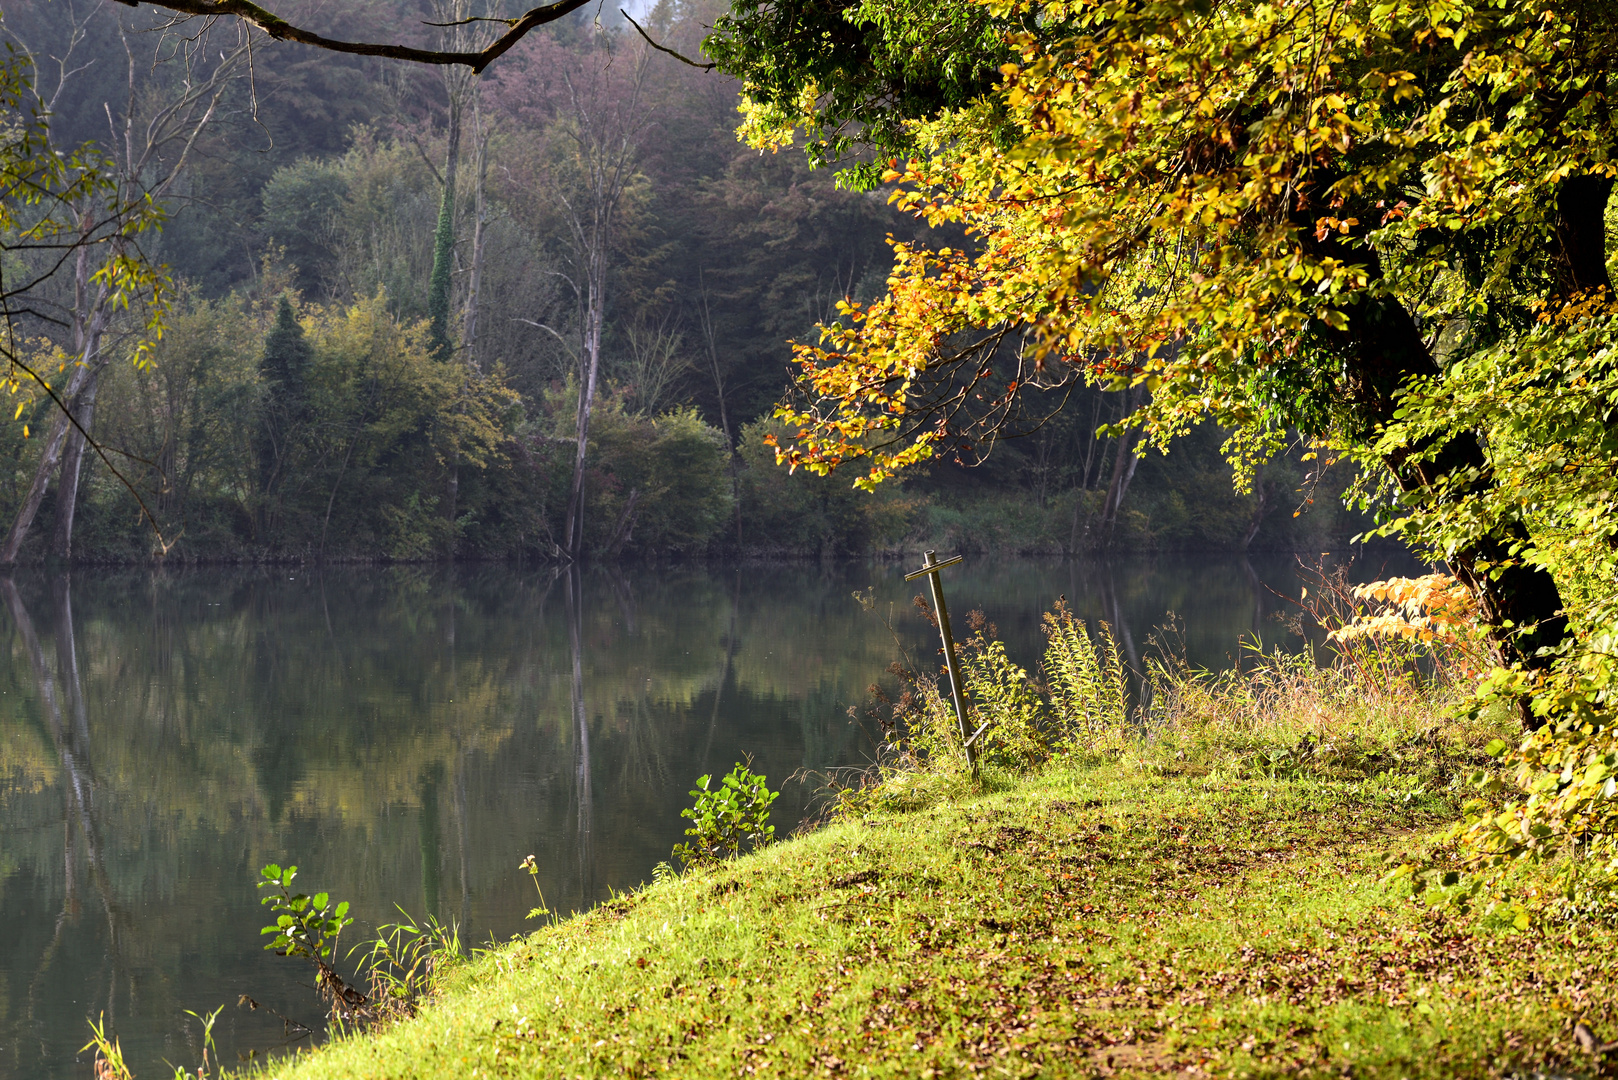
[{"x1": 0, "y1": 0, "x2": 1364, "y2": 562}]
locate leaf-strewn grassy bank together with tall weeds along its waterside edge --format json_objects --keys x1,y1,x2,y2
[{"x1": 59, "y1": 578, "x2": 1566, "y2": 1078}]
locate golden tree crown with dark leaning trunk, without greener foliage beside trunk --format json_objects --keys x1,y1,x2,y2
[{"x1": 741, "y1": 0, "x2": 1612, "y2": 693}]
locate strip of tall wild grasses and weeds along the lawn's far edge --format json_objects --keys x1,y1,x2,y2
[{"x1": 838, "y1": 568, "x2": 1498, "y2": 811}]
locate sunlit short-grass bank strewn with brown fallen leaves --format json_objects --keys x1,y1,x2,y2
[{"x1": 239, "y1": 701, "x2": 1618, "y2": 1080}]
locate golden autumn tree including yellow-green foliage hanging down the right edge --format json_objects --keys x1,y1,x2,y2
[{"x1": 708, "y1": 0, "x2": 1618, "y2": 893}]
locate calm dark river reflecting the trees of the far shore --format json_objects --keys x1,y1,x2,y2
[{"x1": 0, "y1": 557, "x2": 1411, "y2": 1080}]
